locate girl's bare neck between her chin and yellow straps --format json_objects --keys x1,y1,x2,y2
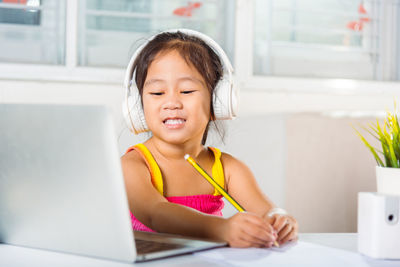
[{"x1": 145, "y1": 137, "x2": 205, "y2": 160}]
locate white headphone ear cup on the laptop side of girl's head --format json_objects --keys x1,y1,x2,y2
[{"x1": 122, "y1": 85, "x2": 149, "y2": 134}]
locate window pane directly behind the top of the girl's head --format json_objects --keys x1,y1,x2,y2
[{"x1": 78, "y1": 0, "x2": 235, "y2": 67}]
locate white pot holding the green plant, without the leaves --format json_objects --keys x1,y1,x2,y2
[{"x1": 376, "y1": 166, "x2": 400, "y2": 195}]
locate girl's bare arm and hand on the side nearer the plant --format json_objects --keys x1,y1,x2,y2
[{"x1": 221, "y1": 153, "x2": 298, "y2": 244}]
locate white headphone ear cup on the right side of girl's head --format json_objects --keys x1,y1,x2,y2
[{"x1": 213, "y1": 78, "x2": 237, "y2": 120}]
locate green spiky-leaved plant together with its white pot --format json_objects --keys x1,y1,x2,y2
[{"x1": 355, "y1": 103, "x2": 400, "y2": 195}]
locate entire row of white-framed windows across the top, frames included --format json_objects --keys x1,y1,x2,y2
[{"x1": 0, "y1": 0, "x2": 400, "y2": 88}]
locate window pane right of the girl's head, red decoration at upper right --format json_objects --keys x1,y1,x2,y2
[{"x1": 253, "y1": 0, "x2": 400, "y2": 80}]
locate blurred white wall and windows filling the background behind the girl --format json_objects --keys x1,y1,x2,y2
[{"x1": 0, "y1": 0, "x2": 400, "y2": 232}]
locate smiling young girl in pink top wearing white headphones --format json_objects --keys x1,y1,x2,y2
[{"x1": 122, "y1": 30, "x2": 298, "y2": 247}]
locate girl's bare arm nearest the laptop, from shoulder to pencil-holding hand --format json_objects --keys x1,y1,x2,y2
[{"x1": 122, "y1": 152, "x2": 276, "y2": 247}]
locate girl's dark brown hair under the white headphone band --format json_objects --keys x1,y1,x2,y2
[{"x1": 132, "y1": 31, "x2": 223, "y2": 145}]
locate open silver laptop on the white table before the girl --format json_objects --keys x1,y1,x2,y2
[{"x1": 0, "y1": 104, "x2": 226, "y2": 262}]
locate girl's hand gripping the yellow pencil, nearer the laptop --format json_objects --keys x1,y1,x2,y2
[{"x1": 222, "y1": 212, "x2": 277, "y2": 248}]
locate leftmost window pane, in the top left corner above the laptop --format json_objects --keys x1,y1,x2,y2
[{"x1": 0, "y1": 0, "x2": 65, "y2": 65}]
